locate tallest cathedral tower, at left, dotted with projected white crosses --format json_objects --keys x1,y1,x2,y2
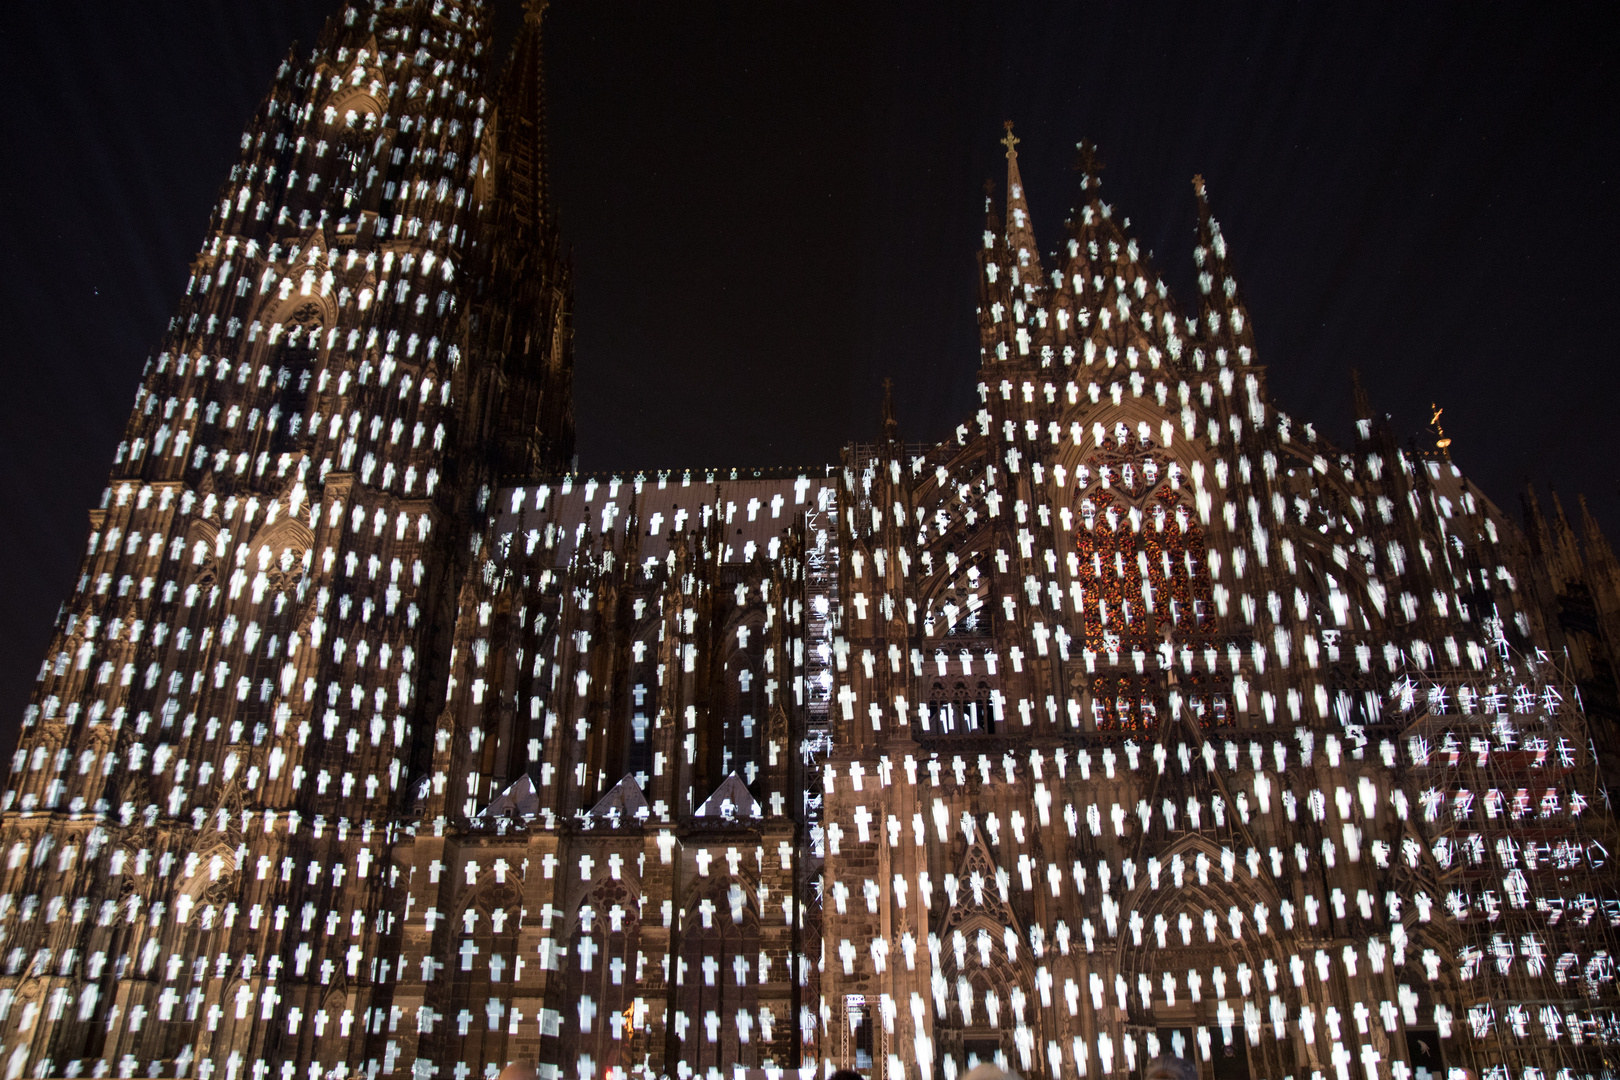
[{"x1": 0, "y1": 0, "x2": 573, "y2": 1077}]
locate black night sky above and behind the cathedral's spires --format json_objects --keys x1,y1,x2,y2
[{"x1": 0, "y1": 0, "x2": 1620, "y2": 757}]
